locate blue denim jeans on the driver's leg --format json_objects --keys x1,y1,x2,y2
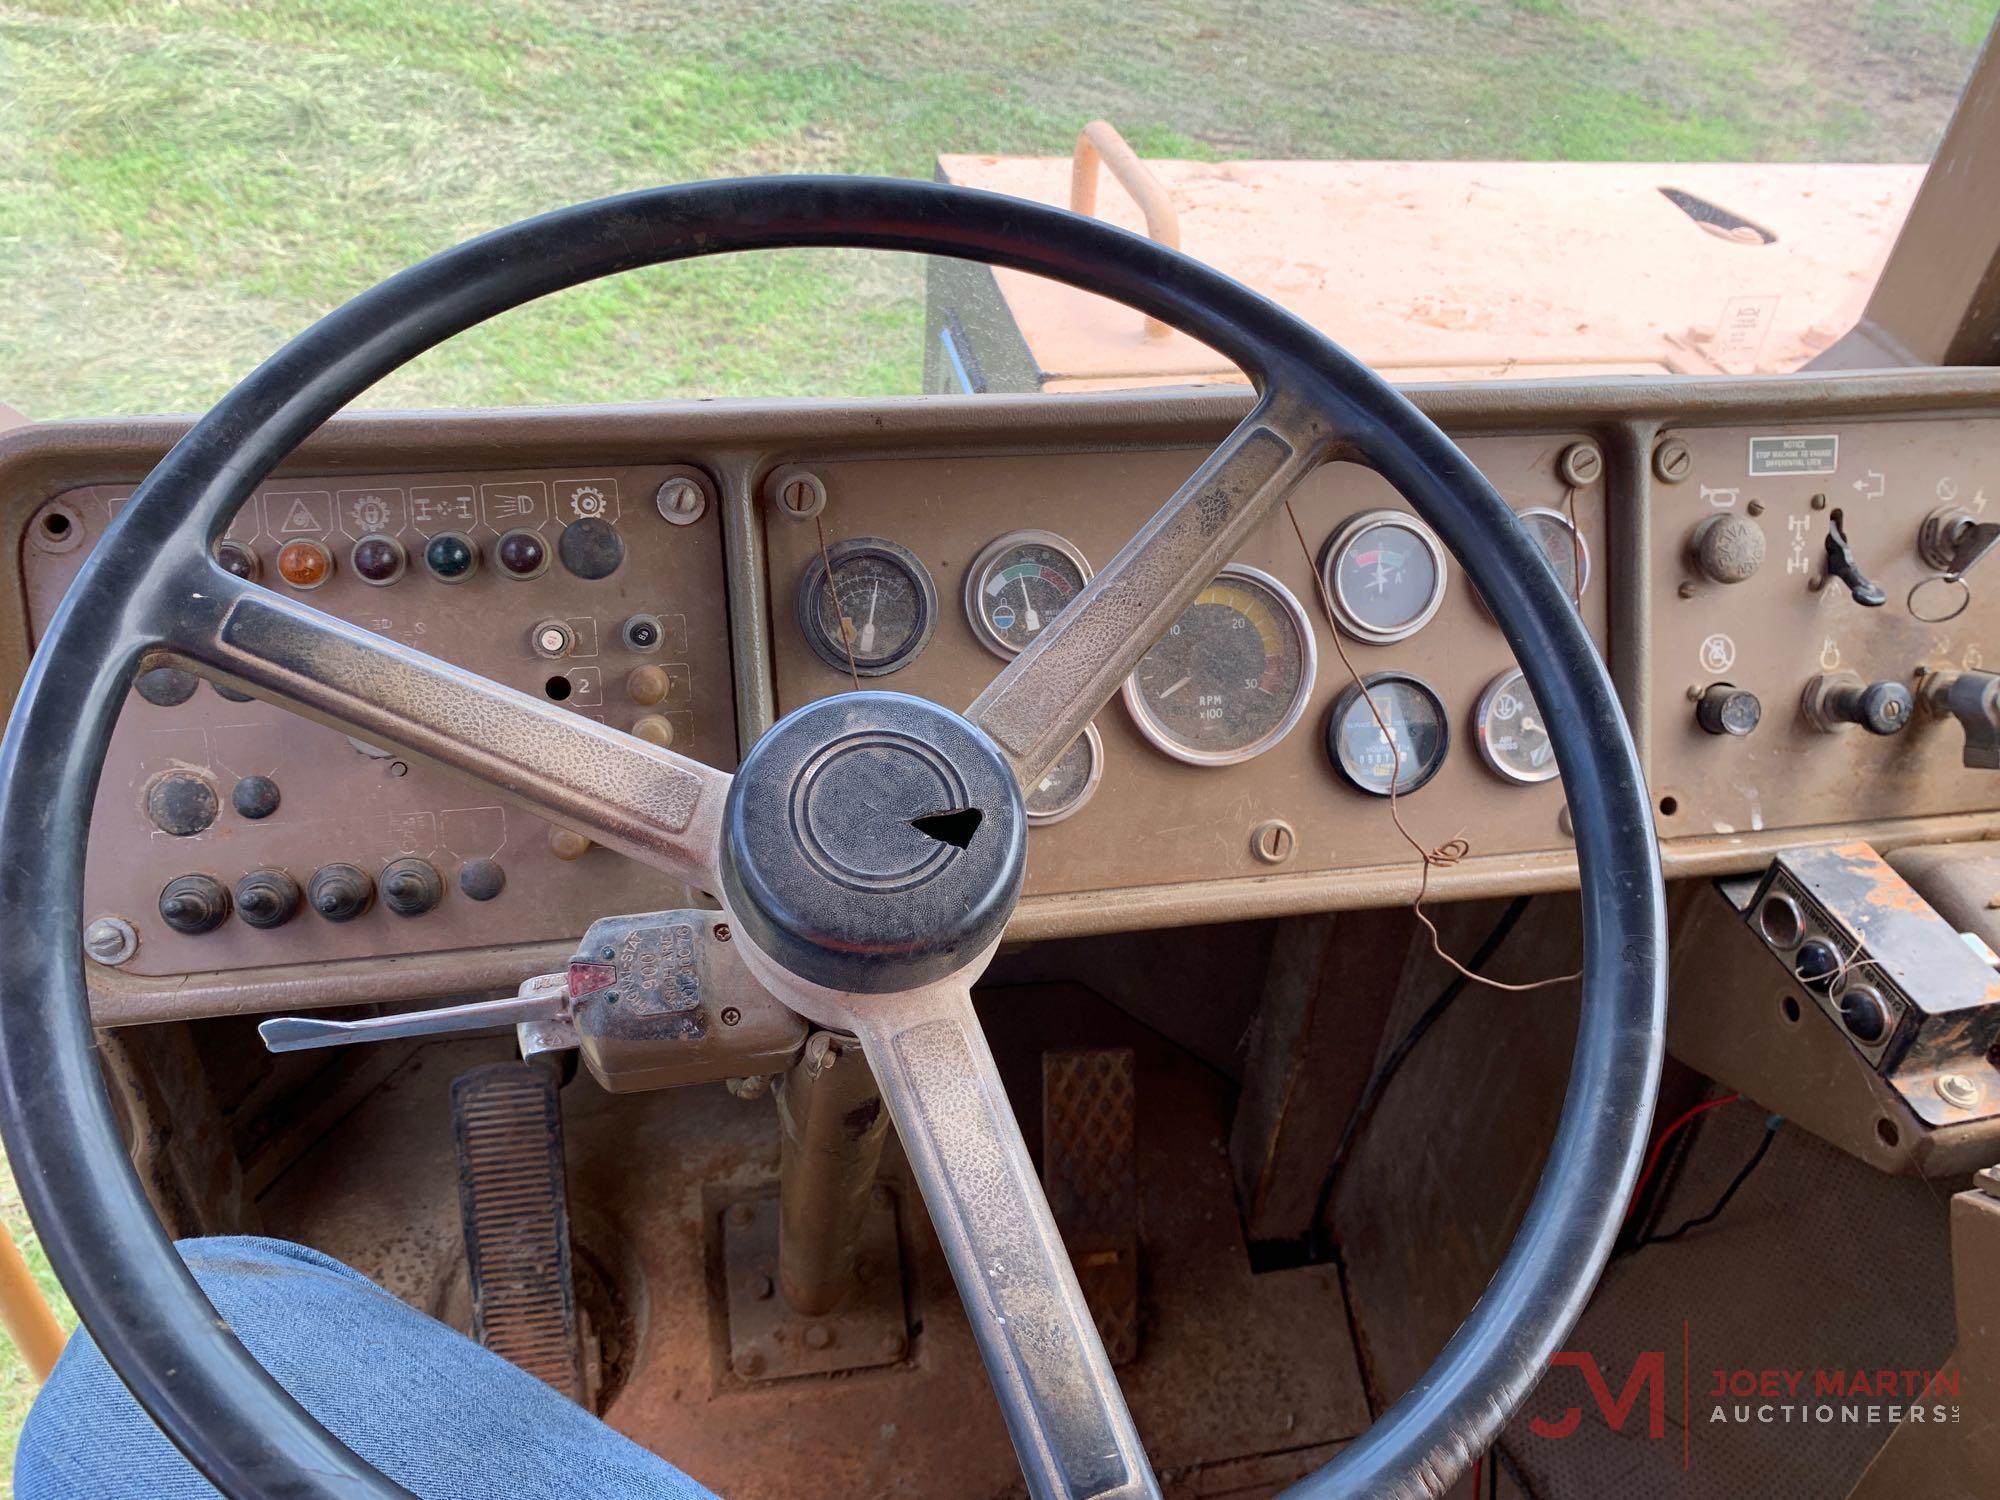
[{"x1": 14, "y1": 1238, "x2": 712, "y2": 1500}]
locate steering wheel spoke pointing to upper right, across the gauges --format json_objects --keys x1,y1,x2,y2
[{"x1": 966, "y1": 390, "x2": 1330, "y2": 788}]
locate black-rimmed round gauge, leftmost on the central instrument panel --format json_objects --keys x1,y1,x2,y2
[{"x1": 798, "y1": 536, "x2": 938, "y2": 678}]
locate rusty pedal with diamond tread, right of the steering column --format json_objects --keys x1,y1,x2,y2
[{"x1": 1042, "y1": 1046, "x2": 1138, "y2": 1364}]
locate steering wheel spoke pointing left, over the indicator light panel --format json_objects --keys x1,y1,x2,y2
[{"x1": 164, "y1": 564, "x2": 730, "y2": 890}]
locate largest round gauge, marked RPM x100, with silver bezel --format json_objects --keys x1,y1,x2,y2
[{"x1": 1124, "y1": 564, "x2": 1318, "y2": 766}]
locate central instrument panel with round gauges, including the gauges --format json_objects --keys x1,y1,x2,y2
[{"x1": 762, "y1": 436, "x2": 1606, "y2": 894}]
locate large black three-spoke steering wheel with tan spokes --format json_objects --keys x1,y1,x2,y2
[{"x1": 0, "y1": 178, "x2": 1664, "y2": 1496}]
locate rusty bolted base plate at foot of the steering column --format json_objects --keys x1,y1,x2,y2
[{"x1": 710, "y1": 1186, "x2": 910, "y2": 1384}]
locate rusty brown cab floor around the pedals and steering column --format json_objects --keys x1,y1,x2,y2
[{"x1": 262, "y1": 986, "x2": 1368, "y2": 1500}]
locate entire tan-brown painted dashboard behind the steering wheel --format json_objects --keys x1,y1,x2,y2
[{"x1": 11, "y1": 372, "x2": 2000, "y2": 1022}]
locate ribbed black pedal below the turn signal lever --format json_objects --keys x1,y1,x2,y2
[{"x1": 452, "y1": 1062, "x2": 588, "y2": 1404}]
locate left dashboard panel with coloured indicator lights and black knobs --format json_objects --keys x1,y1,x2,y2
[{"x1": 22, "y1": 464, "x2": 736, "y2": 976}]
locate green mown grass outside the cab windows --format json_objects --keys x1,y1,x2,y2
[{"x1": 0, "y1": 0, "x2": 2000, "y2": 1472}]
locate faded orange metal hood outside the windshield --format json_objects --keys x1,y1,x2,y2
[{"x1": 938, "y1": 156, "x2": 1924, "y2": 390}]
